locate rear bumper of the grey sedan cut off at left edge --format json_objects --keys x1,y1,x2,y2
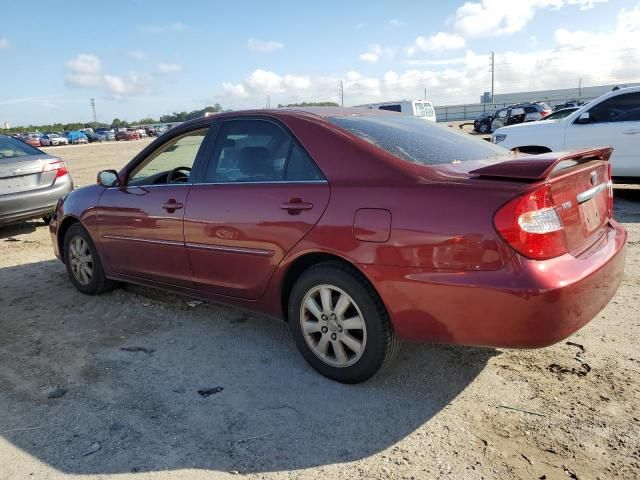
[{"x1": 0, "y1": 175, "x2": 73, "y2": 225}]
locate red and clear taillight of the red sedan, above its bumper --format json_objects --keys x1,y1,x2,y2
[{"x1": 493, "y1": 186, "x2": 567, "y2": 260}]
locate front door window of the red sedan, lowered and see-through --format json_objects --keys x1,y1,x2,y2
[{"x1": 128, "y1": 128, "x2": 208, "y2": 185}]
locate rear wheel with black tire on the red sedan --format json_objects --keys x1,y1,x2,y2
[{"x1": 288, "y1": 262, "x2": 399, "y2": 383}]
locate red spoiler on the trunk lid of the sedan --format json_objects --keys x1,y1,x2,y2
[{"x1": 469, "y1": 147, "x2": 613, "y2": 181}]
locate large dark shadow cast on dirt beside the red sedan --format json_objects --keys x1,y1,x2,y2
[{"x1": 0, "y1": 260, "x2": 497, "y2": 474}]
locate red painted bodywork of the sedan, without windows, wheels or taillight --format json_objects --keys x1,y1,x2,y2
[{"x1": 51, "y1": 109, "x2": 626, "y2": 347}]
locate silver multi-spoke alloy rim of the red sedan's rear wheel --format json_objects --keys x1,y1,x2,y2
[{"x1": 300, "y1": 285, "x2": 367, "y2": 367}]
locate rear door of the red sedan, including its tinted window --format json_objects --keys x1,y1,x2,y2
[{"x1": 184, "y1": 117, "x2": 329, "y2": 299}]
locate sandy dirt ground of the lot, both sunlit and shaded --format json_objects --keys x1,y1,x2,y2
[{"x1": 0, "y1": 137, "x2": 640, "y2": 480}]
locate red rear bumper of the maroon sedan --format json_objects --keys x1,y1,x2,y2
[{"x1": 361, "y1": 221, "x2": 627, "y2": 348}]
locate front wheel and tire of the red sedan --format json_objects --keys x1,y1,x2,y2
[{"x1": 63, "y1": 223, "x2": 117, "y2": 295}]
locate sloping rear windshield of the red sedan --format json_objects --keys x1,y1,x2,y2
[{"x1": 329, "y1": 115, "x2": 509, "y2": 165}]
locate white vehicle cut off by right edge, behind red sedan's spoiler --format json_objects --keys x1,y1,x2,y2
[{"x1": 491, "y1": 87, "x2": 640, "y2": 182}]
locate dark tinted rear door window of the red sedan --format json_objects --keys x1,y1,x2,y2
[{"x1": 205, "y1": 120, "x2": 323, "y2": 183}]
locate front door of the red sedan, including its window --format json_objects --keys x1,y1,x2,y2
[{"x1": 98, "y1": 128, "x2": 208, "y2": 286}]
